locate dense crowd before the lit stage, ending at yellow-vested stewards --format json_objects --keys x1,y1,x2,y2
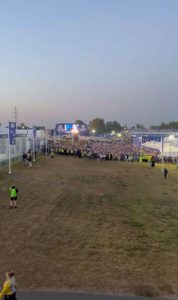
[{"x1": 42, "y1": 140, "x2": 160, "y2": 161}]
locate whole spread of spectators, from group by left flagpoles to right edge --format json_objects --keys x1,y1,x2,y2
[{"x1": 22, "y1": 140, "x2": 178, "y2": 167}]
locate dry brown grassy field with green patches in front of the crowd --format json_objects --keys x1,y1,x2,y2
[{"x1": 0, "y1": 156, "x2": 178, "y2": 296}]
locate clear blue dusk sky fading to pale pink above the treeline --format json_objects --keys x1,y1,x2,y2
[{"x1": 0, "y1": 0, "x2": 178, "y2": 127}]
